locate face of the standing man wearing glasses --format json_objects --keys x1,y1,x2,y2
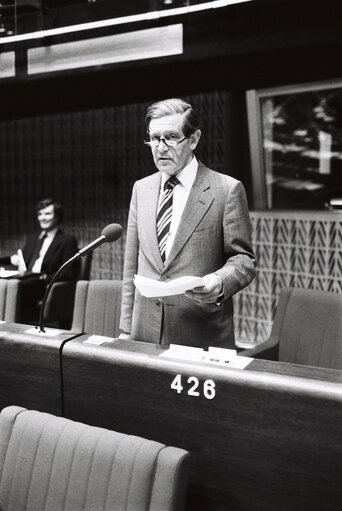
[{"x1": 149, "y1": 114, "x2": 201, "y2": 176}]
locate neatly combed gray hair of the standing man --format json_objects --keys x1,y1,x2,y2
[{"x1": 145, "y1": 98, "x2": 199, "y2": 137}]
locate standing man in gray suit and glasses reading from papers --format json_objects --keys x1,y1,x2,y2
[{"x1": 120, "y1": 99, "x2": 255, "y2": 348}]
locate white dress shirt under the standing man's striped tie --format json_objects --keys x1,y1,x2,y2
[{"x1": 159, "y1": 156, "x2": 198, "y2": 259}]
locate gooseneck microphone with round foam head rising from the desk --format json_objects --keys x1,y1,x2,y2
[{"x1": 39, "y1": 224, "x2": 122, "y2": 333}]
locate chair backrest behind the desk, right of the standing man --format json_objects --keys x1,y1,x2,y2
[{"x1": 271, "y1": 288, "x2": 342, "y2": 369}]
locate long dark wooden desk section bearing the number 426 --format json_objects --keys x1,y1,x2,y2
[{"x1": 63, "y1": 336, "x2": 342, "y2": 511}]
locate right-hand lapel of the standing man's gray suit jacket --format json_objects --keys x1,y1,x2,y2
[{"x1": 164, "y1": 163, "x2": 214, "y2": 269}]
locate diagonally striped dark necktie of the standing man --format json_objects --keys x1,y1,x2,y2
[{"x1": 157, "y1": 176, "x2": 179, "y2": 261}]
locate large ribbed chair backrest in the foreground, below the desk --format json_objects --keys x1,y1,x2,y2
[{"x1": 0, "y1": 406, "x2": 189, "y2": 511}]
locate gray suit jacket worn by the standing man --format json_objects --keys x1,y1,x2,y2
[{"x1": 120, "y1": 163, "x2": 255, "y2": 348}]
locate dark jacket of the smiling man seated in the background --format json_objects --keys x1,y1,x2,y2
[{"x1": 0, "y1": 229, "x2": 79, "y2": 281}]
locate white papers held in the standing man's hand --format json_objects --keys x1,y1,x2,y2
[{"x1": 133, "y1": 275, "x2": 204, "y2": 298}]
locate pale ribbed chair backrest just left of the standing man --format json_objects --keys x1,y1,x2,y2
[{"x1": 72, "y1": 280, "x2": 122, "y2": 337}]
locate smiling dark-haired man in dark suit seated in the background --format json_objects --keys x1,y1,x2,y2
[{"x1": 0, "y1": 199, "x2": 79, "y2": 323}]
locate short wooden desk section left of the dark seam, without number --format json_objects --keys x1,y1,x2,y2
[{"x1": 0, "y1": 322, "x2": 79, "y2": 415}]
